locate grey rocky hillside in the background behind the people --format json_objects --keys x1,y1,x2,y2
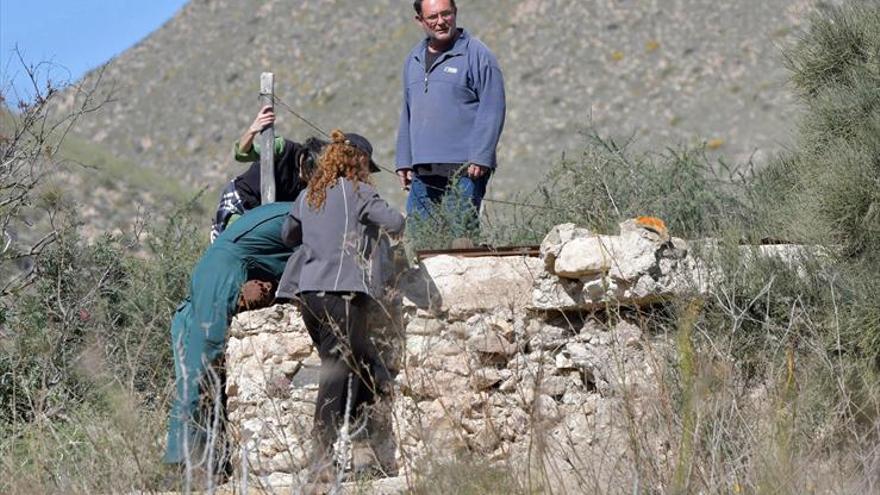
[{"x1": 65, "y1": 0, "x2": 813, "y2": 211}]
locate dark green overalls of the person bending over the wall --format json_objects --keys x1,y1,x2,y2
[{"x1": 163, "y1": 202, "x2": 293, "y2": 465}]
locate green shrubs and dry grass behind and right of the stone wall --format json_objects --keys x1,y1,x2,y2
[{"x1": 402, "y1": 2, "x2": 880, "y2": 493}]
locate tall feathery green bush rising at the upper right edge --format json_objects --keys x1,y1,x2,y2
[{"x1": 768, "y1": 1, "x2": 880, "y2": 261}]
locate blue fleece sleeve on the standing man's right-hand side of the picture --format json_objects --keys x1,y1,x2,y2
[{"x1": 468, "y1": 53, "x2": 507, "y2": 167}]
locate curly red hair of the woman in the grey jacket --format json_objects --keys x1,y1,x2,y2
[{"x1": 306, "y1": 129, "x2": 373, "y2": 210}]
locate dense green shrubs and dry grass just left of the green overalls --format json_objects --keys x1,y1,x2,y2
[{"x1": 0, "y1": 200, "x2": 207, "y2": 493}]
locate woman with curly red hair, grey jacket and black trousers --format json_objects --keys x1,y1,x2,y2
[{"x1": 279, "y1": 130, "x2": 405, "y2": 488}]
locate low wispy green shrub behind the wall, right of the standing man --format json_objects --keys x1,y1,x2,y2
[{"x1": 407, "y1": 132, "x2": 763, "y2": 249}]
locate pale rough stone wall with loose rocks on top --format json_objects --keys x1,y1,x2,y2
[{"x1": 226, "y1": 221, "x2": 812, "y2": 492}]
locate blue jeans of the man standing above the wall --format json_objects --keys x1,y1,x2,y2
[{"x1": 406, "y1": 170, "x2": 492, "y2": 237}]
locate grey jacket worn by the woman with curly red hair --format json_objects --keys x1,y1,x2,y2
[{"x1": 277, "y1": 178, "x2": 405, "y2": 298}]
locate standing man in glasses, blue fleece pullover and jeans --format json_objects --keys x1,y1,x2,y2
[{"x1": 397, "y1": 0, "x2": 505, "y2": 233}]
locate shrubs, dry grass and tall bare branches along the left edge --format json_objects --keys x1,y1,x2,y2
[{"x1": 0, "y1": 58, "x2": 205, "y2": 493}]
